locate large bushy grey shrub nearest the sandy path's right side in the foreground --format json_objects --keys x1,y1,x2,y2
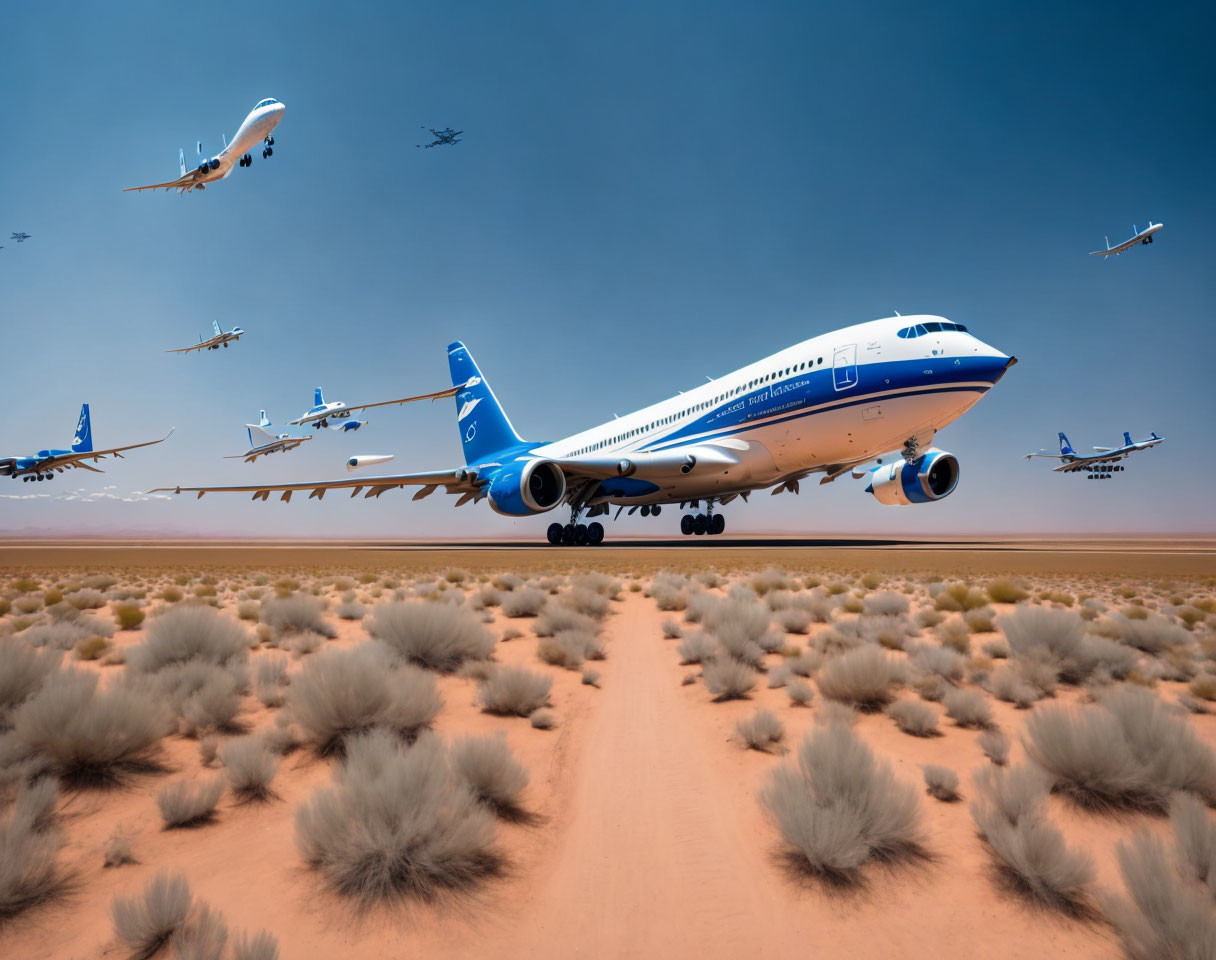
[{"x1": 760, "y1": 723, "x2": 923, "y2": 883}]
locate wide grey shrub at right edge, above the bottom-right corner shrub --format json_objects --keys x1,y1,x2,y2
[{"x1": 1025, "y1": 684, "x2": 1216, "y2": 812}]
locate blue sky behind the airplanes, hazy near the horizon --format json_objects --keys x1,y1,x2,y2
[{"x1": 0, "y1": 2, "x2": 1216, "y2": 537}]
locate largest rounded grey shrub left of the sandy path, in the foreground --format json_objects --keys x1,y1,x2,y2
[{"x1": 295, "y1": 731, "x2": 502, "y2": 905}]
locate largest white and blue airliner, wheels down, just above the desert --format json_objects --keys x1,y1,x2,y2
[{"x1": 152, "y1": 316, "x2": 1017, "y2": 545}]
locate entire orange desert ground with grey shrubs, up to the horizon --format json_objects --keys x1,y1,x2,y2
[{"x1": 0, "y1": 539, "x2": 1216, "y2": 960}]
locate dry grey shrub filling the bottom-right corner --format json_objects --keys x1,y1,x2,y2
[{"x1": 1103, "y1": 830, "x2": 1216, "y2": 960}]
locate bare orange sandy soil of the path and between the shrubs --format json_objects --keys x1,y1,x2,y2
[{"x1": 0, "y1": 556, "x2": 1216, "y2": 960}]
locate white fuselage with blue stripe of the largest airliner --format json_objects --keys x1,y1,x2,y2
[{"x1": 479, "y1": 316, "x2": 1014, "y2": 504}]
